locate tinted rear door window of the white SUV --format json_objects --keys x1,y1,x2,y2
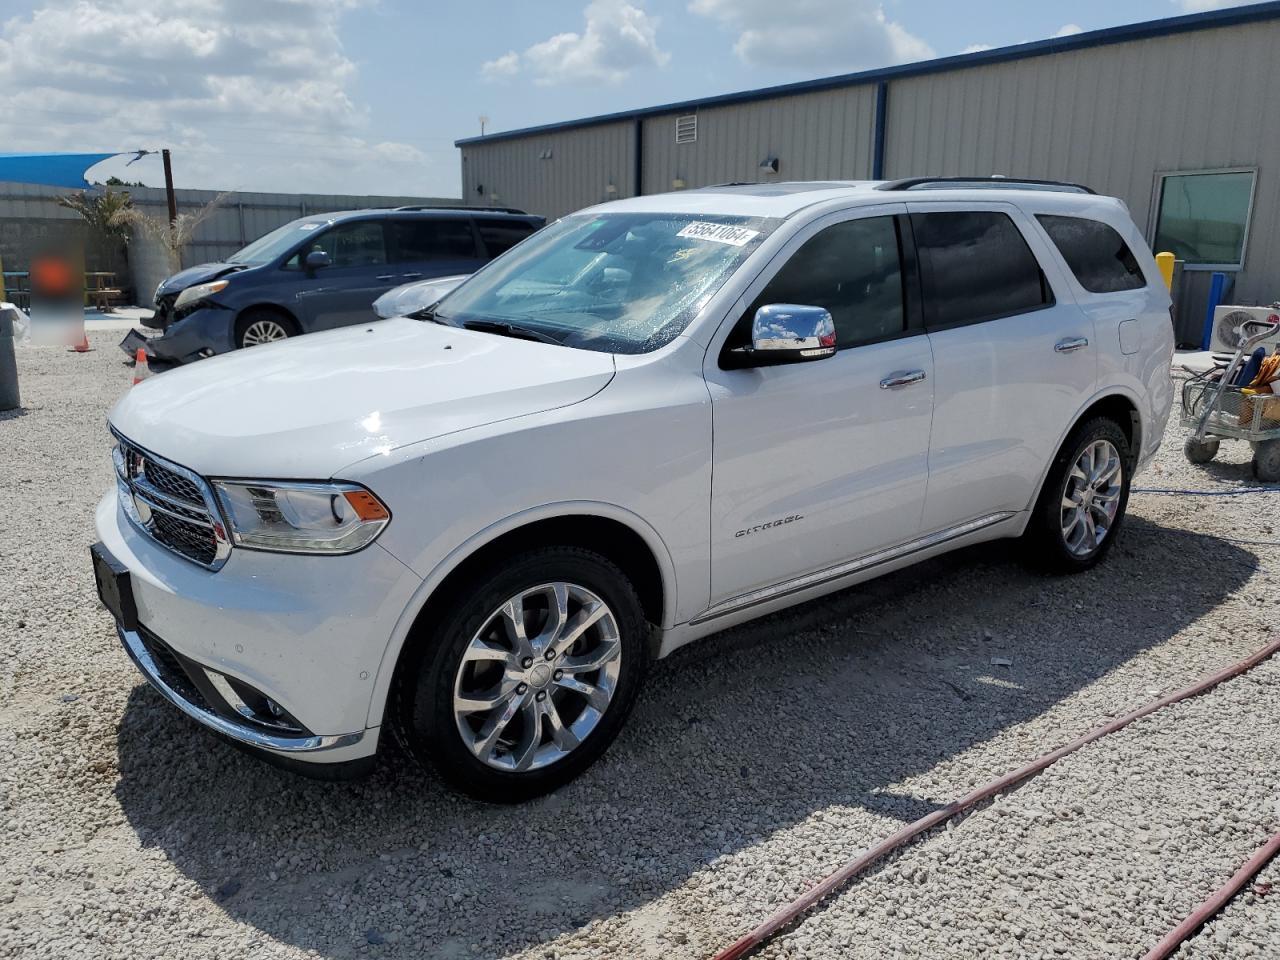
[{"x1": 911, "y1": 210, "x2": 1053, "y2": 326}]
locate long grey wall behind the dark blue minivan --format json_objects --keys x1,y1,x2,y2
[{"x1": 0, "y1": 183, "x2": 462, "y2": 302}]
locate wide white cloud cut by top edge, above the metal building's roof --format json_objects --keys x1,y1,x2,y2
[{"x1": 689, "y1": 0, "x2": 934, "y2": 73}]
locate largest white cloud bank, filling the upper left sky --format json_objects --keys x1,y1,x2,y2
[{"x1": 0, "y1": 0, "x2": 456, "y2": 195}]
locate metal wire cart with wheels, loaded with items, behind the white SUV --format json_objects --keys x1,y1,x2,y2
[{"x1": 1183, "y1": 320, "x2": 1280, "y2": 483}]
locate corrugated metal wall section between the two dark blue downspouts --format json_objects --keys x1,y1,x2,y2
[{"x1": 644, "y1": 86, "x2": 876, "y2": 193}]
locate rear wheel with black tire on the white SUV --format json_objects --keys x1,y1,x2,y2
[{"x1": 1023, "y1": 417, "x2": 1134, "y2": 573}]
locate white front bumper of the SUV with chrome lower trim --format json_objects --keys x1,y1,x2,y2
[{"x1": 96, "y1": 488, "x2": 421, "y2": 764}]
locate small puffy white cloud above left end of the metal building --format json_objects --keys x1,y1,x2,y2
[{"x1": 480, "y1": 0, "x2": 671, "y2": 86}]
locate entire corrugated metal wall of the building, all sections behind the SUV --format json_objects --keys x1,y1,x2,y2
[{"x1": 461, "y1": 19, "x2": 1280, "y2": 302}]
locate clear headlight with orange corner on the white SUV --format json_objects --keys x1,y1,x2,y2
[{"x1": 212, "y1": 480, "x2": 392, "y2": 553}]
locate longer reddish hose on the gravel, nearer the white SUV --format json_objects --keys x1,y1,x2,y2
[{"x1": 713, "y1": 639, "x2": 1280, "y2": 960}]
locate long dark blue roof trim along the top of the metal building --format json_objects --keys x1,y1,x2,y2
[{"x1": 453, "y1": 0, "x2": 1280, "y2": 147}]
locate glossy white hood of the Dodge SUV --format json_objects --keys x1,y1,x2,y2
[{"x1": 110, "y1": 319, "x2": 614, "y2": 480}]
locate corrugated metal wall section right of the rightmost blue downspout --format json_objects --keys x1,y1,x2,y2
[{"x1": 884, "y1": 20, "x2": 1280, "y2": 302}]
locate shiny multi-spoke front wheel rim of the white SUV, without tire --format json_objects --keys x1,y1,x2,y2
[{"x1": 453, "y1": 582, "x2": 622, "y2": 773}]
